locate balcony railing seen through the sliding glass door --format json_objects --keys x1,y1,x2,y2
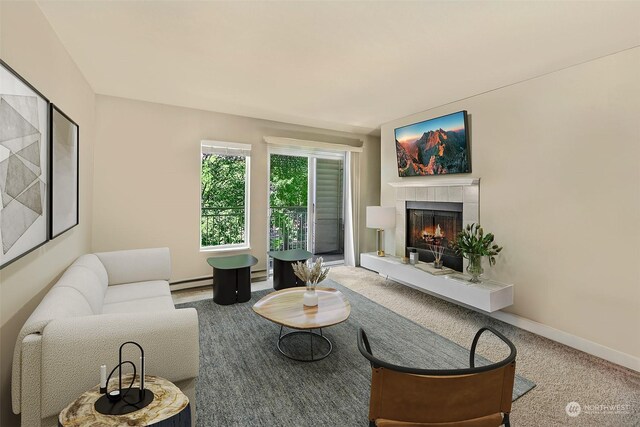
[{"x1": 269, "y1": 206, "x2": 307, "y2": 251}]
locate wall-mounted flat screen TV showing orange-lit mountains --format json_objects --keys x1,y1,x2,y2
[{"x1": 395, "y1": 111, "x2": 471, "y2": 177}]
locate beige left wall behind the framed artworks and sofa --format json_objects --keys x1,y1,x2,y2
[{"x1": 0, "y1": 1, "x2": 95, "y2": 426}]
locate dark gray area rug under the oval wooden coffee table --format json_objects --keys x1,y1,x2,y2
[{"x1": 178, "y1": 280, "x2": 535, "y2": 427}]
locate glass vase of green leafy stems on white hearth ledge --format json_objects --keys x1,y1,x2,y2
[{"x1": 454, "y1": 224, "x2": 502, "y2": 283}]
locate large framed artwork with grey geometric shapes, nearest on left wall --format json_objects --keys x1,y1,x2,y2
[{"x1": 0, "y1": 60, "x2": 49, "y2": 268}]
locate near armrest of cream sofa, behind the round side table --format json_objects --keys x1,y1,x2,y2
[{"x1": 41, "y1": 308, "x2": 199, "y2": 418}]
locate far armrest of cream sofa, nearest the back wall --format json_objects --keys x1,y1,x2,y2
[{"x1": 95, "y1": 248, "x2": 171, "y2": 285}]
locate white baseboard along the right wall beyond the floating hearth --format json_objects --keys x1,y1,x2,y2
[{"x1": 485, "y1": 311, "x2": 640, "y2": 372}]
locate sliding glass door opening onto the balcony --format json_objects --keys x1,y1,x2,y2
[{"x1": 269, "y1": 150, "x2": 344, "y2": 262}]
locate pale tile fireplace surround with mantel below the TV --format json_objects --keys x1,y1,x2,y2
[{"x1": 389, "y1": 177, "x2": 480, "y2": 260}]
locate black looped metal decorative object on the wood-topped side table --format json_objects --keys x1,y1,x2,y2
[{"x1": 95, "y1": 341, "x2": 155, "y2": 415}]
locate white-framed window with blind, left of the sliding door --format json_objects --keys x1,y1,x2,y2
[{"x1": 200, "y1": 141, "x2": 251, "y2": 250}]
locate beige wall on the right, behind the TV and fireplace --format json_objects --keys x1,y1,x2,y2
[{"x1": 381, "y1": 48, "x2": 640, "y2": 357}]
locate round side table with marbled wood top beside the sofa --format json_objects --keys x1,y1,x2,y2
[{"x1": 58, "y1": 374, "x2": 191, "y2": 427}]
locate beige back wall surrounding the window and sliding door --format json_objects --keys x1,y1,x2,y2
[{"x1": 92, "y1": 96, "x2": 380, "y2": 281}]
